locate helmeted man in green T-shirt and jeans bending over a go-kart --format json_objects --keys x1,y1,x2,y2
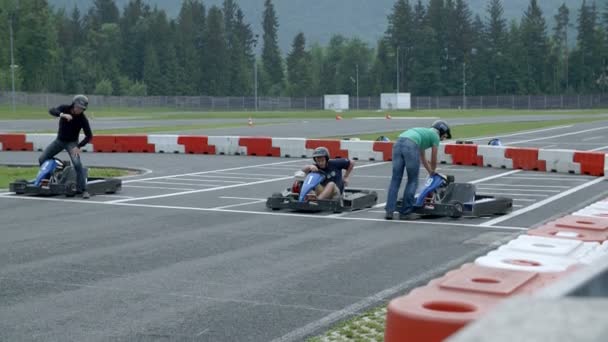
[{"x1": 384, "y1": 120, "x2": 452, "y2": 220}]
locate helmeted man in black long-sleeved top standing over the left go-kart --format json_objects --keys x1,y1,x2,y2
[{"x1": 38, "y1": 95, "x2": 93, "y2": 198}]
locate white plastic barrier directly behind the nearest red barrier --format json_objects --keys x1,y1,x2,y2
[{"x1": 475, "y1": 250, "x2": 578, "y2": 273}]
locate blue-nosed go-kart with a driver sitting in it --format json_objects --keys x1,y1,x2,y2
[{"x1": 266, "y1": 171, "x2": 378, "y2": 213}]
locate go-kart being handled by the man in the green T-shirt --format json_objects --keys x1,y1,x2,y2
[{"x1": 397, "y1": 174, "x2": 513, "y2": 218}]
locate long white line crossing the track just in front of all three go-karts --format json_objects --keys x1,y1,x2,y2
[{"x1": 0, "y1": 196, "x2": 528, "y2": 231}]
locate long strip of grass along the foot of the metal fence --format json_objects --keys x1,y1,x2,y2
[{"x1": 0, "y1": 105, "x2": 608, "y2": 120}]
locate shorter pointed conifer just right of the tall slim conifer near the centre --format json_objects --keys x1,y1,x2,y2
[{"x1": 287, "y1": 32, "x2": 312, "y2": 97}]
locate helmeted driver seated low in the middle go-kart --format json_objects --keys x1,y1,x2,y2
[{"x1": 302, "y1": 147, "x2": 355, "y2": 200}]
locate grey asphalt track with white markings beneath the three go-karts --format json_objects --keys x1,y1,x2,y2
[{"x1": 0, "y1": 120, "x2": 608, "y2": 342}]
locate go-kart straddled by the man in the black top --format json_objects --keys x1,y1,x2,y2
[{"x1": 9, "y1": 158, "x2": 122, "y2": 197}]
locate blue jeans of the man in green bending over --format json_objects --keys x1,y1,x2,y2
[{"x1": 385, "y1": 138, "x2": 420, "y2": 215}]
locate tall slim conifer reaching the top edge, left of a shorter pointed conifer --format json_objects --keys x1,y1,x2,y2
[{"x1": 262, "y1": 0, "x2": 284, "y2": 96}]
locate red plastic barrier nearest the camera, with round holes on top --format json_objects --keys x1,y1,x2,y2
[{"x1": 384, "y1": 264, "x2": 573, "y2": 342}]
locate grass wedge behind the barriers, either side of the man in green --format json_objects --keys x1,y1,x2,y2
[{"x1": 332, "y1": 118, "x2": 608, "y2": 141}]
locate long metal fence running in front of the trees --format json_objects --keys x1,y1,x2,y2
[{"x1": 0, "y1": 92, "x2": 608, "y2": 111}]
